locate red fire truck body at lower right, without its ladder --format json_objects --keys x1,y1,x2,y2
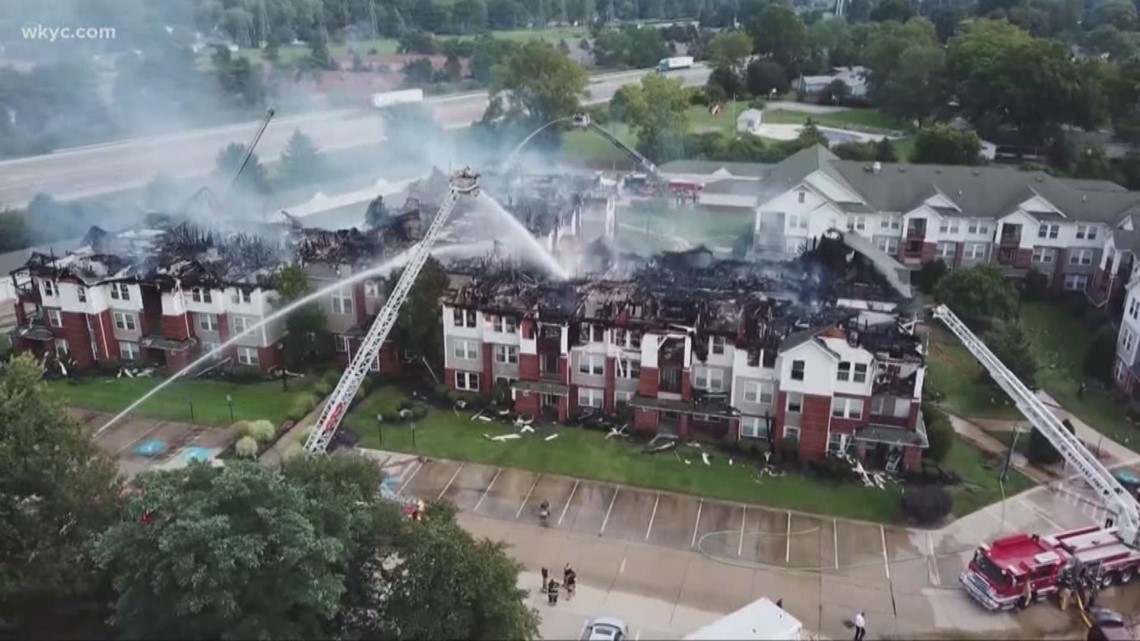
[{"x1": 959, "y1": 526, "x2": 1140, "y2": 610}]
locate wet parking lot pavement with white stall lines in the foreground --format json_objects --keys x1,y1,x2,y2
[{"x1": 372, "y1": 452, "x2": 1134, "y2": 639}]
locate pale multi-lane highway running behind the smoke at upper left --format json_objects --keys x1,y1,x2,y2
[{"x1": 0, "y1": 66, "x2": 709, "y2": 205}]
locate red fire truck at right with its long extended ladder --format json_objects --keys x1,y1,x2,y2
[{"x1": 934, "y1": 306, "x2": 1140, "y2": 632}]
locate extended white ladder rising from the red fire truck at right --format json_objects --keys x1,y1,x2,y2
[{"x1": 934, "y1": 305, "x2": 1140, "y2": 545}]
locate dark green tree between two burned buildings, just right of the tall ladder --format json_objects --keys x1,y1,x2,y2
[{"x1": 389, "y1": 257, "x2": 448, "y2": 366}]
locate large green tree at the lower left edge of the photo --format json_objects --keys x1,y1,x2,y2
[{"x1": 0, "y1": 356, "x2": 119, "y2": 639}]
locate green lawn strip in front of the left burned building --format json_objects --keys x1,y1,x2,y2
[{"x1": 50, "y1": 376, "x2": 315, "y2": 425}]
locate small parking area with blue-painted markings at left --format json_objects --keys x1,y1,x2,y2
[{"x1": 68, "y1": 409, "x2": 234, "y2": 477}]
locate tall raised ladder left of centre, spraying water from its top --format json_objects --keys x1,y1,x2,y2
[{"x1": 304, "y1": 169, "x2": 479, "y2": 454}]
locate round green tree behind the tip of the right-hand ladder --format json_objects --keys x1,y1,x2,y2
[{"x1": 935, "y1": 265, "x2": 1017, "y2": 330}]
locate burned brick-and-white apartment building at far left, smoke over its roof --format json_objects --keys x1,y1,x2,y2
[{"x1": 10, "y1": 207, "x2": 420, "y2": 372}]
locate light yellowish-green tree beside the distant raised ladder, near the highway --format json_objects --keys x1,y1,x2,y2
[{"x1": 627, "y1": 74, "x2": 689, "y2": 162}]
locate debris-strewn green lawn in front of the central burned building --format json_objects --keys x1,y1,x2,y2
[{"x1": 345, "y1": 388, "x2": 1029, "y2": 522}]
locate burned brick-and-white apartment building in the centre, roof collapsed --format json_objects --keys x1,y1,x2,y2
[{"x1": 442, "y1": 234, "x2": 927, "y2": 469}]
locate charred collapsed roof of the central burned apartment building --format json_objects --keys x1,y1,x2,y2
[{"x1": 448, "y1": 237, "x2": 926, "y2": 369}]
